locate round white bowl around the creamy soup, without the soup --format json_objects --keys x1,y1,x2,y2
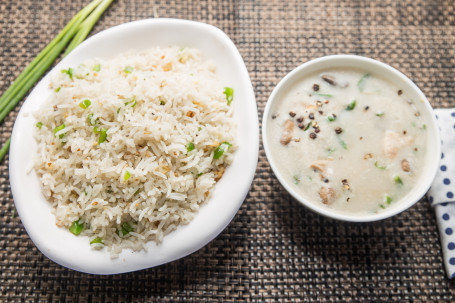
[{"x1": 262, "y1": 55, "x2": 441, "y2": 222}]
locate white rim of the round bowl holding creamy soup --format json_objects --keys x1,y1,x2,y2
[{"x1": 262, "y1": 54, "x2": 441, "y2": 223}]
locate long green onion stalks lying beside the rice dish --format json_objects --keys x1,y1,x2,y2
[{"x1": 0, "y1": 0, "x2": 113, "y2": 161}]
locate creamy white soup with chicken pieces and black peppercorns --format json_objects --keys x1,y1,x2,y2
[{"x1": 266, "y1": 69, "x2": 427, "y2": 215}]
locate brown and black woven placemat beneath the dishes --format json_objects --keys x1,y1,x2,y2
[{"x1": 0, "y1": 0, "x2": 455, "y2": 302}]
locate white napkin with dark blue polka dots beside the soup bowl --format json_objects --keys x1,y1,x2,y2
[{"x1": 428, "y1": 109, "x2": 455, "y2": 279}]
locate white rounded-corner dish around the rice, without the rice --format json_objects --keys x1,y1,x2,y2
[{"x1": 9, "y1": 19, "x2": 259, "y2": 274}]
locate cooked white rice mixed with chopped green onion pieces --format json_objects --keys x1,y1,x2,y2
[{"x1": 34, "y1": 47, "x2": 236, "y2": 257}]
